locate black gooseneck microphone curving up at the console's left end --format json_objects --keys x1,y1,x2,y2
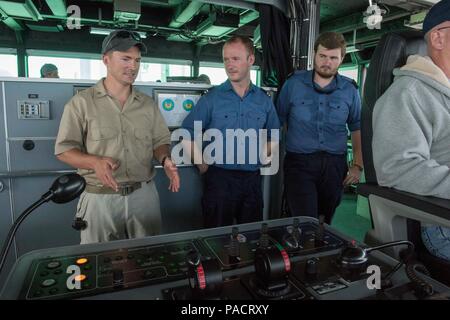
[{"x1": 0, "y1": 173, "x2": 86, "y2": 273}]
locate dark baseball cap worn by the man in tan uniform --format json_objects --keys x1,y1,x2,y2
[{"x1": 102, "y1": 30, "x2": 147, "y2": 54}]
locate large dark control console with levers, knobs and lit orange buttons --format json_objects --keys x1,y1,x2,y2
[{"x1": 1, "y1": 217, "x2": 448, "y2": 300}]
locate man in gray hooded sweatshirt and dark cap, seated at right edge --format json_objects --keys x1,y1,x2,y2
[{"x1": 372, "y1": 0, "x2": 450, "y2": 260}]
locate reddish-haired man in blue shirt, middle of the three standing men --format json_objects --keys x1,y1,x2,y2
[{"x1": 182, "y1": 36, "x2": 280, "y2": 227}]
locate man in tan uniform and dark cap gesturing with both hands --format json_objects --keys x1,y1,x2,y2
[{"x1": 55, "y1": 30, "x2": 180, "y2": 244}]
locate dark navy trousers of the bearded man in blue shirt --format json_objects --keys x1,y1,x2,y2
[{"x1": 284, "y1": 152, "x2": 348, "y2": 224}]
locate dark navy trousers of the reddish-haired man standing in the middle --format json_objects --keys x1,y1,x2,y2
[{"x1": 202, "y1": 166, "x2": 263, "y2": 228}]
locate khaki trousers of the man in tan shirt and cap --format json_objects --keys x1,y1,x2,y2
[{"x1": 76, "y1": 181, "x2": 161, "y2": 244}]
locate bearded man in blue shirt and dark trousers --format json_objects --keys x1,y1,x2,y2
[{"x1": 278, "y1": 32, "x2": 363, "y2": 223}]
